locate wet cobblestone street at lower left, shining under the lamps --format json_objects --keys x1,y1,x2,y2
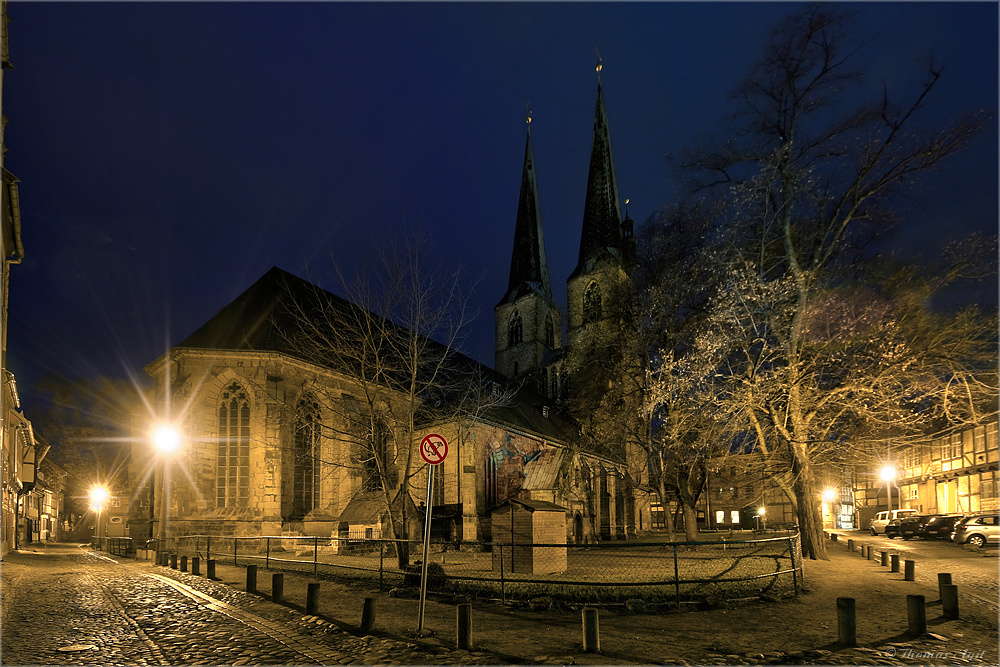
[{"x1": 0, "y1": 547, "x2": 496, "y2": 665}]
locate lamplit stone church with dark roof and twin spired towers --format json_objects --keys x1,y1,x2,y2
[{"x1": 129, "y1": 73, "x2": 636, "y2": 543}]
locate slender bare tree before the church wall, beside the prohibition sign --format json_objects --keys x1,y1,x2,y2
[{"x1": 283, "y1": 231, "x2": 508, "y2": 567}]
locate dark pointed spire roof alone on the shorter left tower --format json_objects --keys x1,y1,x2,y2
[{"x1": 500, "y1": 109, "x2": 552, "y2": 303}]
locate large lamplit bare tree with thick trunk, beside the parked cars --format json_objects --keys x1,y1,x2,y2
[{"x1": 664, "y1": 4, "x2": 985, "y2": 558}]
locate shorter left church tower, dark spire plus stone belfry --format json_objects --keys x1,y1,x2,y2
[{"x1": 493, "y1": 115, "x2": 562, "y2": 390}]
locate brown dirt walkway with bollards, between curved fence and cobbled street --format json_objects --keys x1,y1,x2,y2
[{"x1": 131, "y1": 548, "x2": 997, "y2": 664}]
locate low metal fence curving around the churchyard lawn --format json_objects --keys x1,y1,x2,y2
[{"x1": 97, "y1": 533, "x2": 802, "y2": 607}]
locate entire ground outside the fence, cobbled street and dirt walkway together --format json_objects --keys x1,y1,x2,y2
[{"x1": 0, "y1": 544, "x2": 998, "y2": 665}]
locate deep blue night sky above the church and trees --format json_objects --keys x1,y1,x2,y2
[{"x1": 3, "y1": 0, "x2": 998, "y2": 418}]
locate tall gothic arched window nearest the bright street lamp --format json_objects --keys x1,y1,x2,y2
[{"x1": 215, "y1": 382, "x2": 250, "y2": 507}]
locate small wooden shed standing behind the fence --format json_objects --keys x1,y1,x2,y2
[{"x1": 492, "y1": 498, "x2": 567, "y2": 574}]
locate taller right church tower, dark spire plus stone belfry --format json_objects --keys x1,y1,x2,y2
[{"x1": 566, "y1": 61, "x2": 635, "y2": 351}]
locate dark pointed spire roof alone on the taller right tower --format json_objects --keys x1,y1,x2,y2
[{"x1": 570, "y1": 54, "x2": 622, "y2": 278}]
